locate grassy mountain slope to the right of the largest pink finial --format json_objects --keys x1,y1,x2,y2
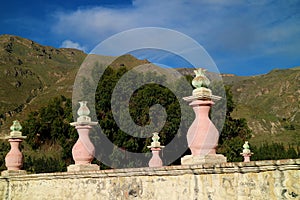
[{"x1": 224, "y1": 67, "x2": 300, "y2": 144}]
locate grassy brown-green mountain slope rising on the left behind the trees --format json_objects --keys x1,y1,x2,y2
[{"x1": 0, "y1": 35, "x2": 149, "y2": 135}]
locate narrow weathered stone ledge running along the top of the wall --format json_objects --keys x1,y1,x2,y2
[{"x1": 0, "y1": 159, "x2": 300, "y2": 180}]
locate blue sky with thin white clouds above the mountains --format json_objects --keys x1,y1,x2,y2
[{"x1": 0, "y1": 0, "x2": 300, "y2": 75}]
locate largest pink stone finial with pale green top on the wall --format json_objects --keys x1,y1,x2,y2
[{"x1": 181, "y1": 69, "x2": 226, "y2": 165}]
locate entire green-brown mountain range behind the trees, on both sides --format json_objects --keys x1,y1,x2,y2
[{"x1": 0, "y1": 35, "x2": 300, "y2": 145}]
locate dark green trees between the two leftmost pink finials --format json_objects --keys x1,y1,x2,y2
[{"x1": 22, "y1": 96, "x2": 78, "y2": 173}]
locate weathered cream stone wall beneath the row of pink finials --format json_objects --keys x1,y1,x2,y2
[{"x1": 0, "y1": 159, "x2": 300, "y2": 200}]
